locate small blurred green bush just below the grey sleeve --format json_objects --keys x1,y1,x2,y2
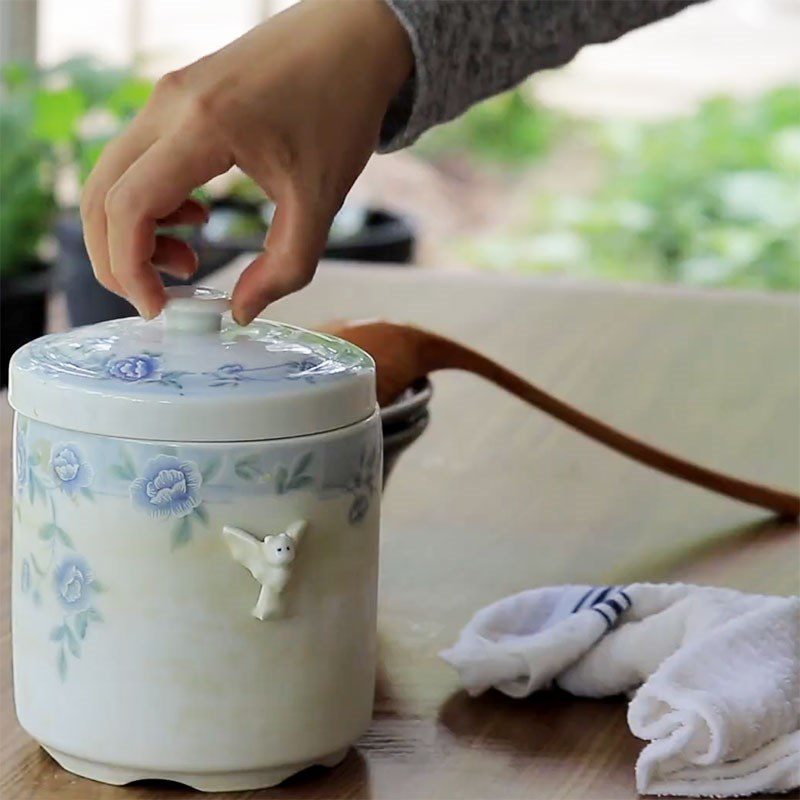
[{"x1": 414, "y1": 87, "x2": 562, "y2": 164}]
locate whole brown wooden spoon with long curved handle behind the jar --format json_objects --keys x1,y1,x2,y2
[{"x1": 322, "y1": 321, "x2": 800, "y2": 519}]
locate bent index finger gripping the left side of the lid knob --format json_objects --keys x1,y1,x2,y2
[{"x1": 105, "y1": 134, "x2": 232, "y2": 319}]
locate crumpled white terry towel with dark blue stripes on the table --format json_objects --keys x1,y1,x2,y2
[{"x1": 441, "y1": 583, "x2": 800, "y2": 797}]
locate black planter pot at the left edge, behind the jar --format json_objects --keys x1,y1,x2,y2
[{"x1": 0, "y1": 264, "x2": 51, "y2": 389}]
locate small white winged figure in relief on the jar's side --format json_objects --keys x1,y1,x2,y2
[{"x1": 222, "y1": 520, "x2": 307, "y2": 620}]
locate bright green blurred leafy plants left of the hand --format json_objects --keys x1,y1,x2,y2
[{"x1": 0, "y1": 57, "x2": 152, "y2": 277}]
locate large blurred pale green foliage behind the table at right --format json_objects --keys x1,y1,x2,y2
[{"x1": 462, "y1": 86, "x2": 800, "y2": 290}]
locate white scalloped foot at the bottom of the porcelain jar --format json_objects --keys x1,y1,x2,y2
[{"x1": 42, "y1": 745, "x2": 350, "y2": 792}]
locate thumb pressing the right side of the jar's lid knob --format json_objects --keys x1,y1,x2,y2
[{"x1": 231, "y1": 189, "x2": 333, "y2": 325}]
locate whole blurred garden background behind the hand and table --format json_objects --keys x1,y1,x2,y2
[{"x1": 0, "y1": 0, "x2": 800, "y2": 382}]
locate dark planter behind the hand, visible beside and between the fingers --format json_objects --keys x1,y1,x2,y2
[{"x1": 55, "y1": 198, "x2": 416, "y2": 325}]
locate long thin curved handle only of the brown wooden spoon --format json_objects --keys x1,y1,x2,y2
[{"x1": 422, "y1": 334, "x2": 800, "y2": 519}]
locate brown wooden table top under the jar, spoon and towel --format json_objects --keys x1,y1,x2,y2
[{"x1": 0, "y1": 265, "x2": 800, "y2": 800}]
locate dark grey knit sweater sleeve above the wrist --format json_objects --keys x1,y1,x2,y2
[{"x1": 379, "y1": 0, "x2": 700, "y2": 152}]
